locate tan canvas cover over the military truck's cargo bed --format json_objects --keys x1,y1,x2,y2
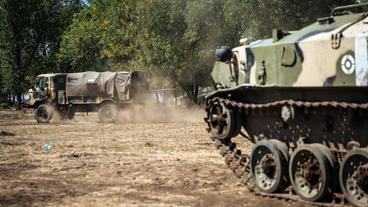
[{"x1": 66, "y1": 72, "x2": 130, "y2": 99}]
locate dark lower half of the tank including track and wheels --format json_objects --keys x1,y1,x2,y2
[{"x1": 205, "y1": 77, "x2": 368, "y2": 206}]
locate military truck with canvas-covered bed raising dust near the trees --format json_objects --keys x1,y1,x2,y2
[{"x1": 27, "y1": 71, "x2": 149, "y2": 123}]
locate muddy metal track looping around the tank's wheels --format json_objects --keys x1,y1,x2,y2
[{"x1": 205, "y1": 97, "x2": 368, "y2": 207}]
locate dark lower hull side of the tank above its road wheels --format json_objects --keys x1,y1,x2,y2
[{"x1": 207, "y1": 85, "x2": 368, "y2": 152}]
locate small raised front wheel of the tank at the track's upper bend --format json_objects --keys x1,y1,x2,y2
[{"x1": 208, "y1": 102, "x2": 241, "y2": 139}]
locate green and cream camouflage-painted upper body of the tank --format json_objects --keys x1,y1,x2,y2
[{"x1": 212, "y1": 10, "x2": 368, "y2": 87}]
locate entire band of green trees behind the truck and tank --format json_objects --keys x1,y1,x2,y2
[{"x1": 0, "y1": 0, "x2": 366, "y2": 106}]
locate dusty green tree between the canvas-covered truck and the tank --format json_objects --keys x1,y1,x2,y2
[{"x1": 132, "y1": 0, "x2": 231, "y2": 103}]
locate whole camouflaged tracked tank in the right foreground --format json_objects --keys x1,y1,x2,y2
[{"x1": 205, "y1": 4, "x2": 368, "y2": 206}]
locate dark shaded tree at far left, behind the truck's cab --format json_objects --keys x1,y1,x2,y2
[{"x1": 0, "y1": 0, "x2": 81, "y2": 109}]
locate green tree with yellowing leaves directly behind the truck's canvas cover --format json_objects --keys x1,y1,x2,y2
[{"x1": 58, "y1": 0, "x2": 136, "y2": 72}]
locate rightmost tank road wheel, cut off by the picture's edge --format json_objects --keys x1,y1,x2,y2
[{"x1": 339, "y1": 149, "x2": 368, "y2": 207}]
